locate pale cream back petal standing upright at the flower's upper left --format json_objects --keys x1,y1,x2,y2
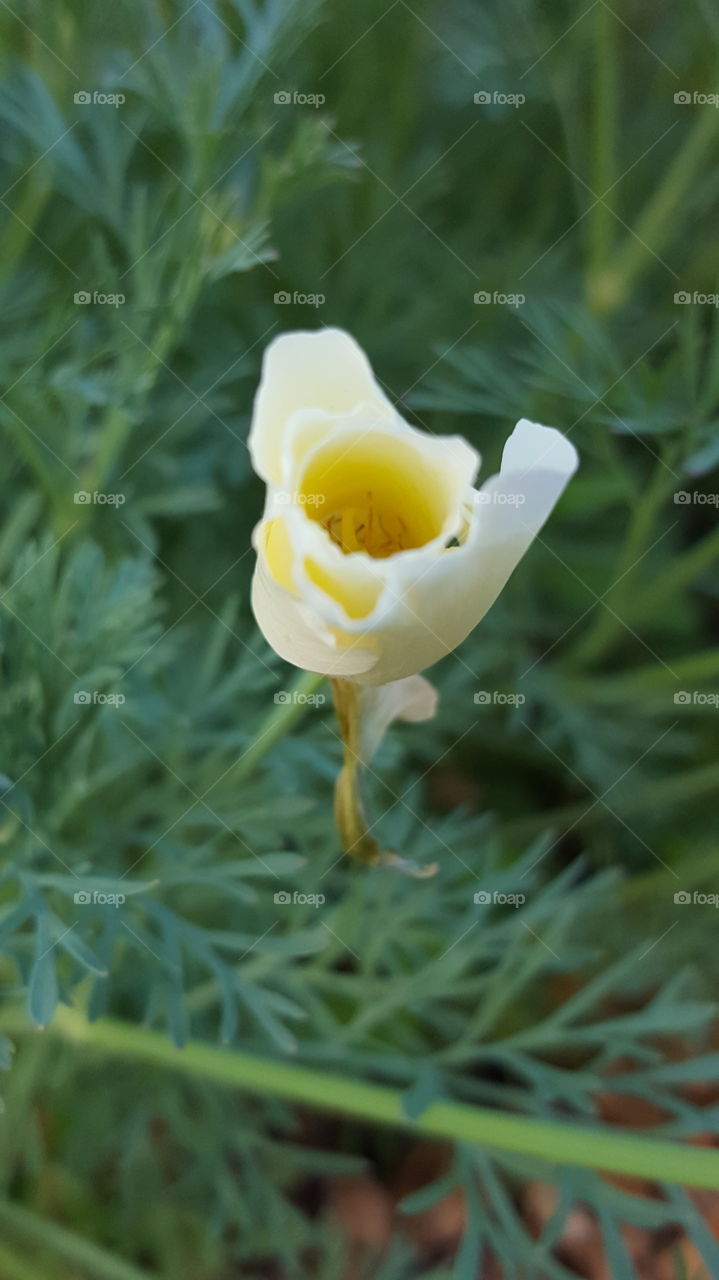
[{"x1": 247, "y1": 329, "x2": 394, "y2": 485}]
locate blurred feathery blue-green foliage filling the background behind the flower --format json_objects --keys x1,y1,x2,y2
[{"x1": 0, "y1": 0, "x2": 719, "y2": 1280}]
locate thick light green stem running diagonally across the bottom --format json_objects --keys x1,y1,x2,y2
[{"x1": 0, "y1": 1007, "x2": 719, "y2": 1187}]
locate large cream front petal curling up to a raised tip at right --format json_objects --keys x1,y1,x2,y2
[{"x1": 253, "y1": 419, "x2": 578, "y2": 686}]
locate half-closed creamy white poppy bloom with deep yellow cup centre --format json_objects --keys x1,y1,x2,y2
[{"x1": 249, "y1": 329, "x2": 578, "y2": 691}]
